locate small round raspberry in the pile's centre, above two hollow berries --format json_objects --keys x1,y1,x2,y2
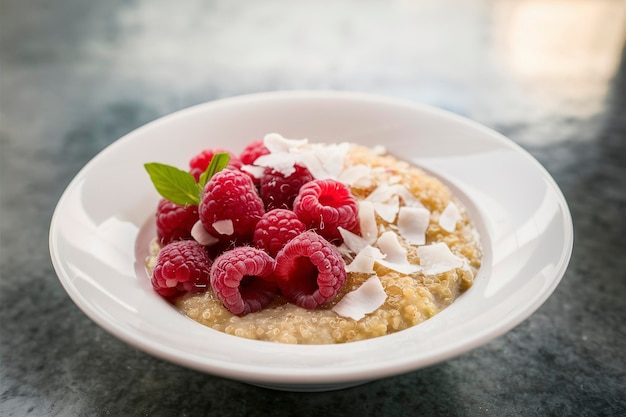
[{"x1": 254, "y1": 209, "x2": 306, "y2": 257}]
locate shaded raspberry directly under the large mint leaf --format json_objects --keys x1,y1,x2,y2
[{"x1": 156, "y1": 199, "x2": 198, "y2": 246}]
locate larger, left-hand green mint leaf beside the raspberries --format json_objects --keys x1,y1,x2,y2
[{"x1": 144, "y1": 158, "x2": 200, "y2": 206}]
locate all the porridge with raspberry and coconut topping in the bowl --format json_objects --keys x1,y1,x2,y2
[{"x1": 146, "y1": 134, "x2": 482, "y2": 344}]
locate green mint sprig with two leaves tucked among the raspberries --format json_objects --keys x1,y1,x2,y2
[{"x1": 144, "y1": 153, "x2": 230, "y2": 206}]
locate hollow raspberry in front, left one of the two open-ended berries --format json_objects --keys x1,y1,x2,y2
[{"x1": 211, "y1": 246, "x2": 278, "y2": 316}]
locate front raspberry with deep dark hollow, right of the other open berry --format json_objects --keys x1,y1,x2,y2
[{"x1": 274, "y1": 230, "x2": 346, "y2": 310}]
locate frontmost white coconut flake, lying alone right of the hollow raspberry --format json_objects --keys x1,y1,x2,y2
[{"x1": 333, "y1": 275, "x2": 387, "y2": 320}]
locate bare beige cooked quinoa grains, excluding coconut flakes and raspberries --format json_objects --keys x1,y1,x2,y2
[{"x1": 147, "y1": 145, "x2": 482, "y2": 344}]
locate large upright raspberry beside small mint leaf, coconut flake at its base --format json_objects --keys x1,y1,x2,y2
[{"x1": 198, "y1": 169, "x2": 265, "y2": 244}]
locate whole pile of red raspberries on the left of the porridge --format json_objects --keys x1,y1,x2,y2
[{"x1": 151, "y1": 140, "x2": 359, "y2": 315}]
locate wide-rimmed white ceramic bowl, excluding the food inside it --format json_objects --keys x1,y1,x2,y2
[{"x1": 50, "y1": 92, "x2": 573, "y2": 391}]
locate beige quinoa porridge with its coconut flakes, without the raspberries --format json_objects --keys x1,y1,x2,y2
[{"x1": 146, "y1": 135, "x2": 482, "y2": 344}]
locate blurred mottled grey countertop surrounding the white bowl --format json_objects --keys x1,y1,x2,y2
[{"x1": 0, "y1": 0, "x2": 626, "y2": 417}]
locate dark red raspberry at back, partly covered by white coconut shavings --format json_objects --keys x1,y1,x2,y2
[{"x1": 261, "y1": 165, "x2": 313, "y2": 210}]
